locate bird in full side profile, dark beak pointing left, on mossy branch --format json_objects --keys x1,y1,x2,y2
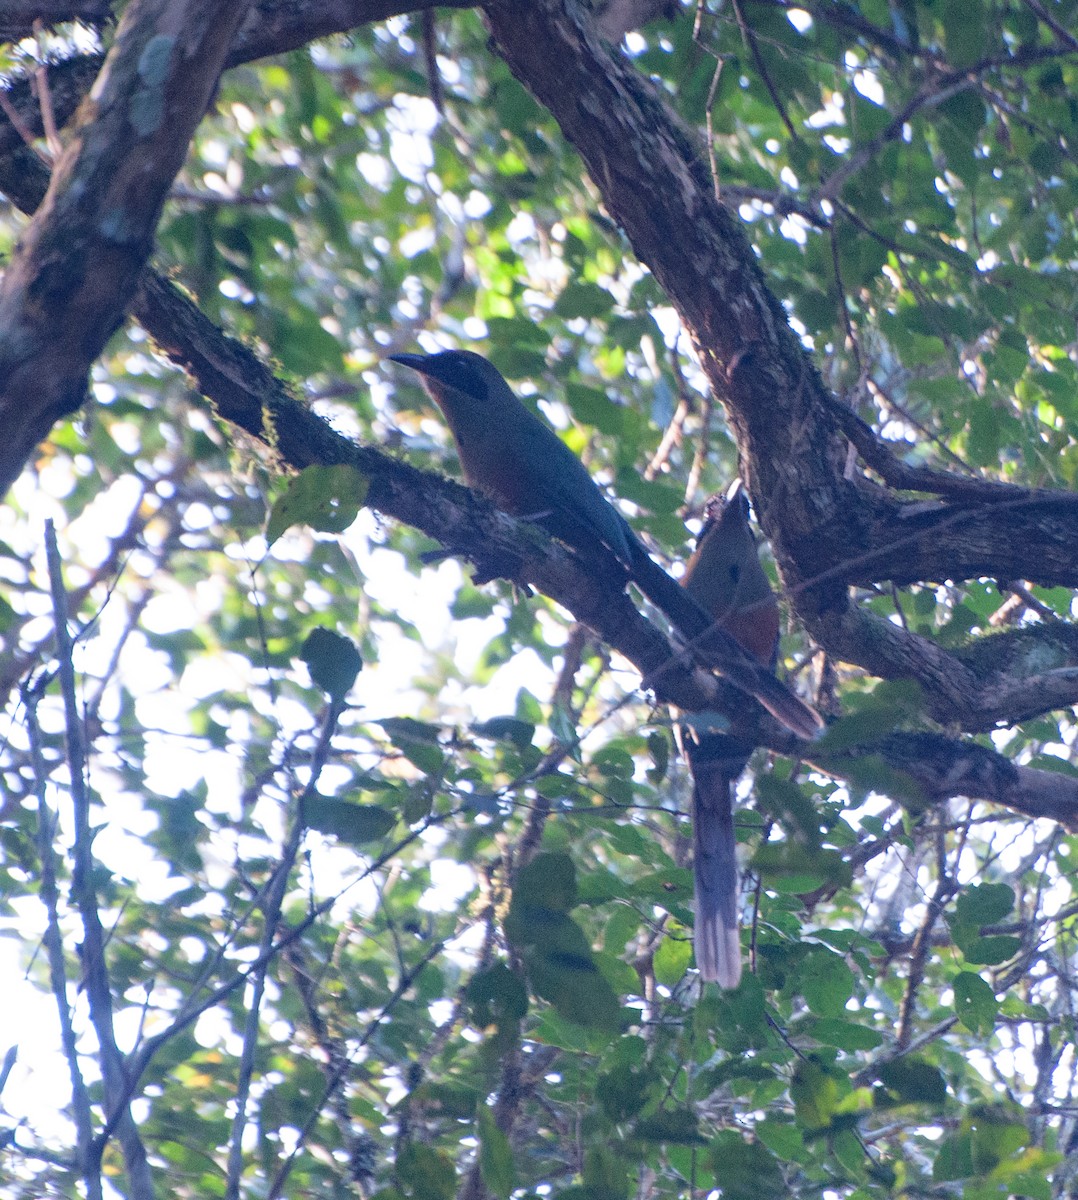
[{"x1": 389, "y1": 350, "x2": 822, "y2": 738}]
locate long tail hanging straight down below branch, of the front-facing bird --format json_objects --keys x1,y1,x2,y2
[{"x1": 685, "y1": 734, "x2": 745, "y2": 988}]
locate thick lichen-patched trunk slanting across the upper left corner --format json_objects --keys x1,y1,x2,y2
[{"x1": 0, "y1": 0, "x2": 246, "y2": 490}]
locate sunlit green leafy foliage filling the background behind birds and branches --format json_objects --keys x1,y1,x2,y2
[{"x1": 0, "y1": 0, "x2": 1078, "y2": 1200}]
